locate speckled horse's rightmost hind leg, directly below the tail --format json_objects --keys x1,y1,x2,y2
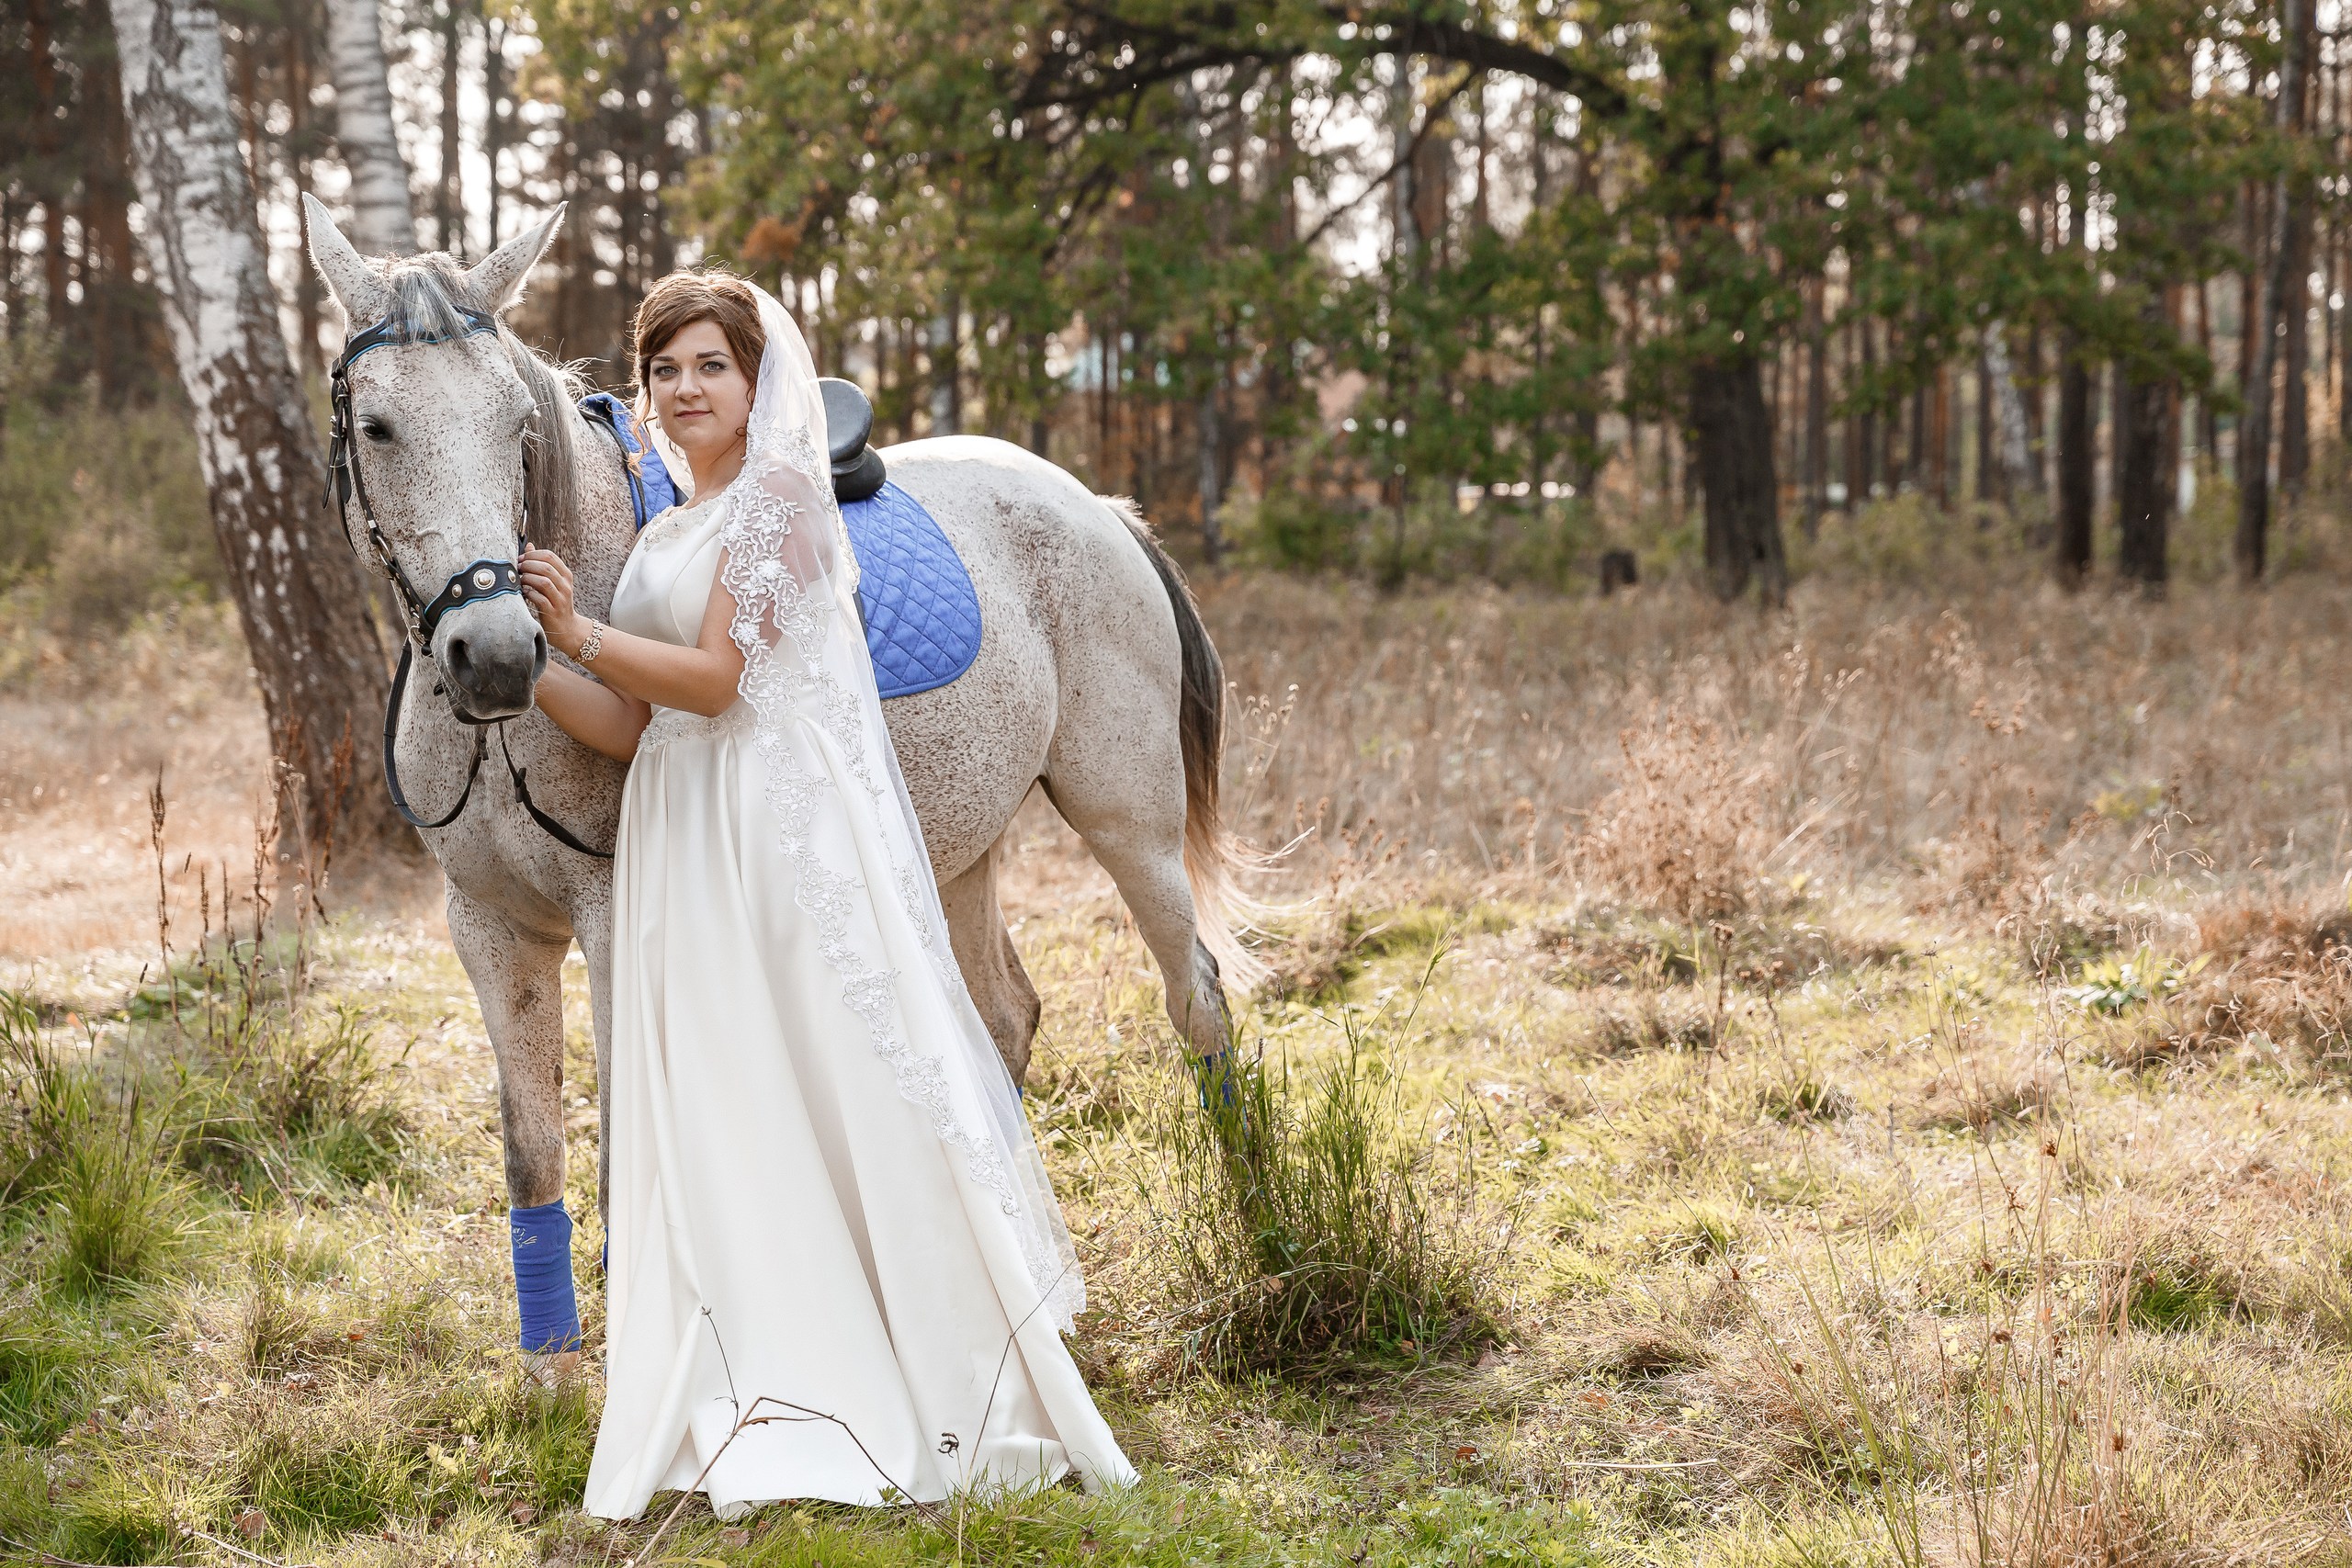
[{"x1": 1045, "y1": 747, "x2": 1232, "y2": 1060}]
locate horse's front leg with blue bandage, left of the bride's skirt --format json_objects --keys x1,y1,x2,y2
[{"x1": 449, "y1": 884, "x2": 581, "y2": 1382}]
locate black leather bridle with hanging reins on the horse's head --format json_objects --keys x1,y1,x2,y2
[{"x1": 327, "y1": 306, "x2": 612, "y2": 861}]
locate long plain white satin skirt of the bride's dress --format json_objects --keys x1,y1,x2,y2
[{"x1": 585, "y1": 703, "x2": 1134, "y2": 1518}]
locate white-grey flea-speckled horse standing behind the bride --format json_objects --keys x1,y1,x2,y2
[{"x1": 306, "y1": 197, "x2": 1239, "y2": 1363}]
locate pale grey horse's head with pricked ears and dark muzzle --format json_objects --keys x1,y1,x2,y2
[{"x1": 303, "y1": 195, "x2": 571, "y2": 722}]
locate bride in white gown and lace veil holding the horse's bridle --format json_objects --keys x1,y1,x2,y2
[{"x1": 522, "y1": 273, "x2": 1134, "y2": 1518}]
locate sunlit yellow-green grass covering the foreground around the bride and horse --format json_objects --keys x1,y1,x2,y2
[{"x1": 0, "y1": 891, "x2": 2352, "y2": 1568}]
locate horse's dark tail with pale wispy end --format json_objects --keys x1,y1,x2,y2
[{"x1": 1105, "y1": 496, "x2": 1268, "y2": 992}]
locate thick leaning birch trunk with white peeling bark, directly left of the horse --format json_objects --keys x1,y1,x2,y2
[{"x1": 113, "y1": 0, "x2": 398, "y2": 856}]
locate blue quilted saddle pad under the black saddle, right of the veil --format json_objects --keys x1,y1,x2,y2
[{"x1": 842, "y1": 484, "x2": 981, "y2": 696}]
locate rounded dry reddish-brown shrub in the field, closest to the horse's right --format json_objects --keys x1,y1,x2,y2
[{"x1": 1566, "y1": 707, "x2": 1771, "y2": 921}]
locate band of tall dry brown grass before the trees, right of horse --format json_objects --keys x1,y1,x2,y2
[{"x1": 1202, "y1": 576, "x2": 2352, "y2": 908}]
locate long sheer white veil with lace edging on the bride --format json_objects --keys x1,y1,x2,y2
[{"x1": 680, "y1": 289, "x2": 1087, "y2": 1333}]
